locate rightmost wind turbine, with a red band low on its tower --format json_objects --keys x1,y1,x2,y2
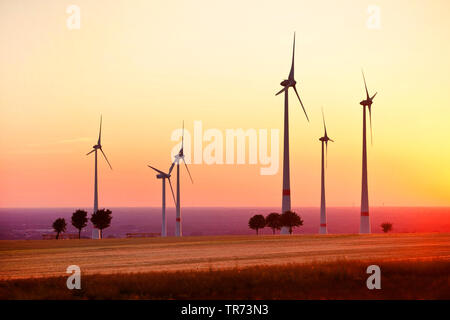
[{"x1": 359, "y1": 70, "x2": 377, "y2": 233}]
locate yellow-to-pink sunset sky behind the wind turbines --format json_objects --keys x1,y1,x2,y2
[{"x1": 0, "y1": 0, "x2": 450, "y2": 207}]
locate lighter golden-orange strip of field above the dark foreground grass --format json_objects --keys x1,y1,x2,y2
[{"x1": 0, "y1": 233, "x2": 450, "y2": 280}]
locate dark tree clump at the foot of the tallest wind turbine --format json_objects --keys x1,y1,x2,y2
[{"x1": 248, "y1": 211, "x2": 303, "y2": 234}]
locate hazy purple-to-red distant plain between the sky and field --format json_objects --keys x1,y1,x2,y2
[{"x1": 0, "y1": 206, "x2": 450, "y2": 239}]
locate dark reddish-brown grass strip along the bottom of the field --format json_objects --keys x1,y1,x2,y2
[{"x1": 0, "y1": 259, "x2": 450, "y2": 300}]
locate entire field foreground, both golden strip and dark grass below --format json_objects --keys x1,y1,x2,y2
[{"x1": 0, "y1": 233, "x2": 450, "y2": 300}]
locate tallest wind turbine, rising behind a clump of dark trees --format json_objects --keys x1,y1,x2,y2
[{"x1": 276, "y1": 33, "x2": 309, "y2": 234}]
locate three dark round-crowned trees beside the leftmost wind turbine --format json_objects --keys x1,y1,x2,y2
[{"x1": 52, "y1": 209, "x2": 112, "y2": 239}]
